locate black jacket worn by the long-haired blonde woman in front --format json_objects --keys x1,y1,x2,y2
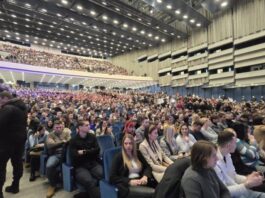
[{"x1": 110, "y1": 151, "x2": 153, "y2": 198}]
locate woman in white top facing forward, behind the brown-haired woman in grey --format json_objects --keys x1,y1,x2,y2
[{"x1": 176, "y1": 124, "x2": 196, "y2": 155}]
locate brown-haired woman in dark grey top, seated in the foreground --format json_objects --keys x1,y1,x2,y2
[{"x1": 181, "y1": 140, "x2": 231, "y2": 198}]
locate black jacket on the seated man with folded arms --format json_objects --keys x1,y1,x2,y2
[{"x1": 69, "y1": 133, "x2": 100, "y2": 167}]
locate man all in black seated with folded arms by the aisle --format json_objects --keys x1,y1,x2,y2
[{"x1": 70, "y1": 120, "x2": 103, "y2": 197}]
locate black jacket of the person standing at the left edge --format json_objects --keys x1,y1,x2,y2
[{"x1": 0, "y1": 98, "x2": 27, "y2": 147}]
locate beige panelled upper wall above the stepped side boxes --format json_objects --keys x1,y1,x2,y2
[{"x1": 111, "y1": 0, "x2": 265, "y2": 80}]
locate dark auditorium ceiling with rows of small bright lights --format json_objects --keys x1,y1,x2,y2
[{"x1": 0, "y1": 0, "x2": 234, "y2": 58}]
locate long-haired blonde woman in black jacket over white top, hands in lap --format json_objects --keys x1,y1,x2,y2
[{"x1": 110, "y1": 133, "x2": 154, "y2": 198}]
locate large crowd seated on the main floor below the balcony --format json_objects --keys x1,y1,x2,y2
[{"x1": 1, "y1": 82, "x2": 265, "y2": 198}]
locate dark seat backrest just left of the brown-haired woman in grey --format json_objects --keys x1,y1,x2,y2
[{"x1": 154, "y1": 158, "x2": 190, "y2": 198}]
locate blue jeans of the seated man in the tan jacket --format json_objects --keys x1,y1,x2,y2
[{"x1": 46, "y1": 155, "x2": 61, "y2": 187}]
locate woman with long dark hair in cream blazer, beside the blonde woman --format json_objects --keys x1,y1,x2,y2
[{"x1": 139, "y1": 125, "x2": 173, "y2": 182}]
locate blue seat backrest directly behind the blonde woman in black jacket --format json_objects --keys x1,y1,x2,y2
[{"x1": 103, "y1": 147, "x2": 121, "y2": 181}]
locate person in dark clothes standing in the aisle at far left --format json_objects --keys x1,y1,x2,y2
[{"x1": 0, "y1": 91, "x2": 27, "y2": 198}]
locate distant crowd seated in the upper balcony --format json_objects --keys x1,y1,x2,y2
[{"x1": 0, "y1": 43, "x2": 128, "y2": 75}]
